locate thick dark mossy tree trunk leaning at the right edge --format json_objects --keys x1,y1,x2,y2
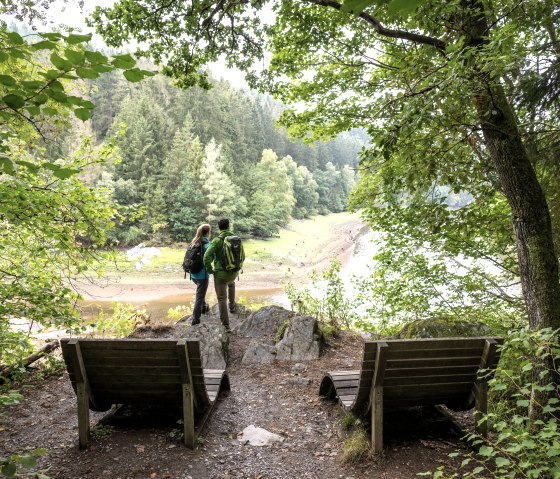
[{"x1": 464, "y1": 0, "x2": 560, "y2": 419}]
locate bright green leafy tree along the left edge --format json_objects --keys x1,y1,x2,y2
[{"x1": 0, "y1": 26, "x2": 149, "y2": 363}]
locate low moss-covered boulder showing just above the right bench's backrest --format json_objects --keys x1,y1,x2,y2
[{"x1": 398, "y1": 316, "x2": 491, "y2": 339}]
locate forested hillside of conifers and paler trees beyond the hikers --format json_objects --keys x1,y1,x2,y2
[{"x1": 42, "y1": 52, "x2": 366, "y2": 244}]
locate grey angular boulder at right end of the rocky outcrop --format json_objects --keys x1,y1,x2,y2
[{"x1": 276, "y1": 316, "x2": 321, "y2": 361}]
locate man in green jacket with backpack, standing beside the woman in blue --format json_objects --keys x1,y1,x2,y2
[{"x1": 204, "y1": 218, "x2": 245, "y2": 332}]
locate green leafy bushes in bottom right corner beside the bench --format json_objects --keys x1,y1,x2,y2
[{"x1": 424, "y1": 328, "x2": 560, "y2": 479}]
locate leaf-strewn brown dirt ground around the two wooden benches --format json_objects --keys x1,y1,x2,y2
[{"x1": 0, "y1": 318, "x2": 471, "y2": 479}]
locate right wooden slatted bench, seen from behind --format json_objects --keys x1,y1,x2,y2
[{"x1": 319, "y1": 338, "x2": 502, "y2": 453}]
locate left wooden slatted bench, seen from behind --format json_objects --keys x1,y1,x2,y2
[{"x1": 60, "y1": 339, "x2": 229, "y2": 449}]
